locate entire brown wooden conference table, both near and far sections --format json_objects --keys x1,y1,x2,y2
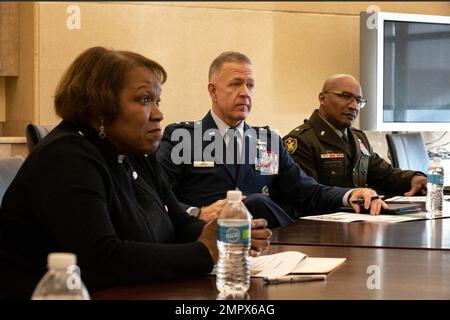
[{"x1": 92, "y1": 198, "x2": 450, "y2": 300}]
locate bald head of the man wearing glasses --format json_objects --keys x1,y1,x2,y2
[{"x1": 319, "y1": 74, "x2": 362, "y2": 130}]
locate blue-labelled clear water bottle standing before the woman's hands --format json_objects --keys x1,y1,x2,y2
[{"x1": 216, "y1": 191, "x2": 252, "y2": 295}]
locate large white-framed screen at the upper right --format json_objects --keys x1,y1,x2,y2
[{"x1": 360, "y1": 12, "x2": 450, "y2": 131}]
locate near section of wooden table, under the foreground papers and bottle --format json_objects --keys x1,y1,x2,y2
[{"x1": 92, "y1": 245, "x2": 450, "y2": 300}]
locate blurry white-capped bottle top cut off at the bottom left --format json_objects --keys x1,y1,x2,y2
[{"x1": 31, "y1": 253, "x2": 90, "y2": 300}]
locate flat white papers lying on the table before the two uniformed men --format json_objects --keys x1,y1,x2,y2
[{"x1": 301, "y1": 212, "x2": 426, "y2": 223}]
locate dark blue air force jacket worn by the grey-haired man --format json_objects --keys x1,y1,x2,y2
[{"x1": 157, "y1": 112, "x2": 349, "y2": 214}]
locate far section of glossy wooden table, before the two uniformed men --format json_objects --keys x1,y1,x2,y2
[{"x1": 271, "y1": 201, "x2": 450, "y2": 250}]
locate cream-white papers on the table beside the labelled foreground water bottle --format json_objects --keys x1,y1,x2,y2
[{"x1": 249, "y1": 251, "x2": 346, "y2": 277}]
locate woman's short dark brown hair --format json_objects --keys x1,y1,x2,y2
[{"x1": 55, "y1": 47, "x2": 167, "y2": 124}]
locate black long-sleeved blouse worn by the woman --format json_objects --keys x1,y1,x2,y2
[{"x1": 0, "y1": 121, "x2": 213, "y2": 297}]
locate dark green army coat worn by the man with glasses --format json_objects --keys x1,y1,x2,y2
[{"x1": 283, "y1": 110, "x2": 422, "y2": 195}]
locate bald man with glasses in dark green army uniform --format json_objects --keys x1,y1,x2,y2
[{"x1": 283, "y1": 74, "x2": 427, "y2": 196}]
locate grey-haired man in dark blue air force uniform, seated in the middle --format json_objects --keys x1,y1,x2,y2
[{"x1": 157, "y1": 52, "x2": 385, "y2": 228}]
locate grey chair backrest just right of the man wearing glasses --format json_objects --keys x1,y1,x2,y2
[{"x1": 386, "y1": 132, "x2": 430, "y2": 172}]
